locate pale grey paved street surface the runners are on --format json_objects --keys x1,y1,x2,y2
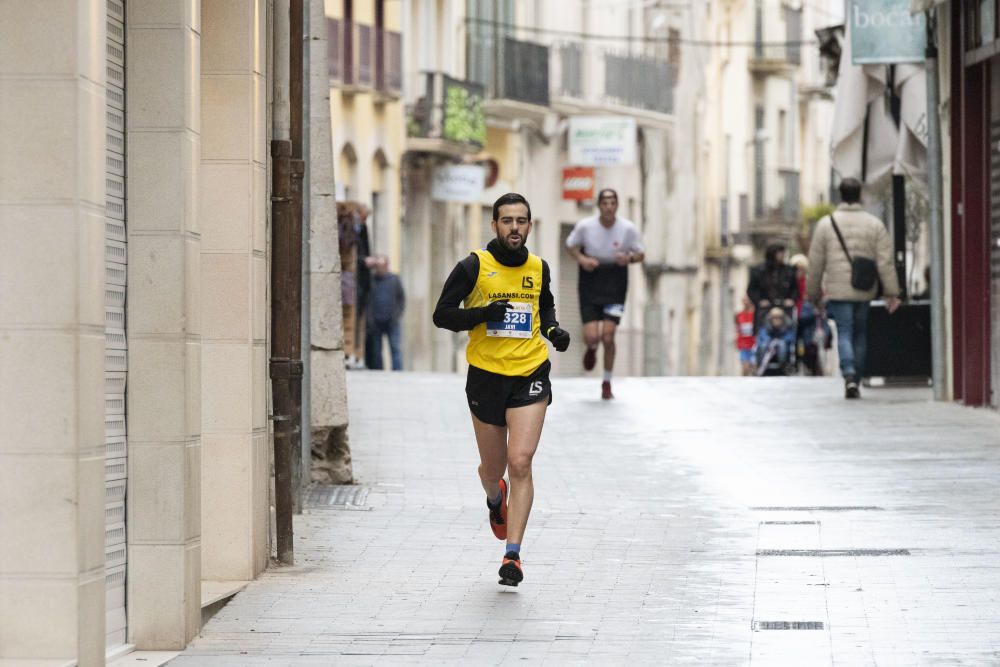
[{"x1": 169, "y1": 373, "x2": 1000, "y2": 667}]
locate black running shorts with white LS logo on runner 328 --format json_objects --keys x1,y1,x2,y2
[{"x1": 465, "y1": 359, "x2": 552, "y2": 426}]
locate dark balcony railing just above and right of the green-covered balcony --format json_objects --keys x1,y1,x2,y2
[{"x1": 466, "y1": 31, "x2": 549, "y2": 107}]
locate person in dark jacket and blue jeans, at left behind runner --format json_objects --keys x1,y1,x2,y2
[{"x1": 365, "y1": 255, "x2": 406, "y2": 371}]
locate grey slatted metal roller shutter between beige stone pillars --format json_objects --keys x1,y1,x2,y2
[{"x1": 104, "y1": 0, "x2": 128, "y2": 652}]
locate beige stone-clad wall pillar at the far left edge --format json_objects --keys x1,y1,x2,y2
[{"x1": 0, "y1": 0, "x2": 105, "y2": 666}]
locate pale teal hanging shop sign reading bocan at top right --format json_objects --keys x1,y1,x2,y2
[{"x1": 848, "y1": 0, "x2": 927, "y2": 65}]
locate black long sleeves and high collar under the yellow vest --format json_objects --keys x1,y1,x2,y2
[{"x1": 434, "y1": 240, "x2": 559, "y2": 335}]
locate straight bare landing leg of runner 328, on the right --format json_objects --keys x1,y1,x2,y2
[{"x1": 507, "y1": 400, "x2": 548, "y2": 544}]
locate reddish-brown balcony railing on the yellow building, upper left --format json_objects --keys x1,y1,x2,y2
[{"x1": 326, "y1": 19, "x2": 403, "y2": 98}]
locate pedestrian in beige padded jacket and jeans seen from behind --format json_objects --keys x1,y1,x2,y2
[{"x1": 806, "y1": 178, "x2": 899, "y2": 398}]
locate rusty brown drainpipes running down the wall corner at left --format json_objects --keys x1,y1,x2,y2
[{"x1": 269, "y1": 0, "x2": 304, "y2": 565}]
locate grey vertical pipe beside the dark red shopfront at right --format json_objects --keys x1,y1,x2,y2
[{"x1": 924, "y1": 9, "x2": 944, "y2": 401}]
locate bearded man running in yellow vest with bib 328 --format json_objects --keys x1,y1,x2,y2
[{"x1": 434, "y1": 193, "x2": 569, "y2": 586}]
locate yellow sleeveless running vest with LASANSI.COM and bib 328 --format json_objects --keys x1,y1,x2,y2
[{"x1": 465, "y1": 250, "x2": 549, "y2": 376}]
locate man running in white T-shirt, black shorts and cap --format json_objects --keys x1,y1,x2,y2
[{"x1": 566, "y1": 188, "x2": 645, "y2": 400}]
